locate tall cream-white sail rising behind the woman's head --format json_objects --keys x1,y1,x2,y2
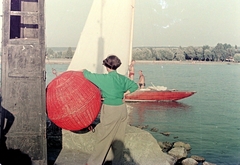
[{"x1": 68, "y1": 0, "x2": 134, "y2": 75}]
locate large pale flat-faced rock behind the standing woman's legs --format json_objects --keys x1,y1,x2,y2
[{"x1": 55, "y1": 126, "x2": 176, "y2": 165}]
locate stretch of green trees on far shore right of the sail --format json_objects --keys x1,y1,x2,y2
[{"x1": 133, "y1": 43, "x2": 238, "y2": 61}]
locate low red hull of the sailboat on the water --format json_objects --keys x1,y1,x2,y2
[{"x1": 125, "y1": 89, "x2": 196, "y2": 102}]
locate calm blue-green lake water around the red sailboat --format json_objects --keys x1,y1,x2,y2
[{"x1": 47, "y1": 63, "x2": 240, "y2": 165}]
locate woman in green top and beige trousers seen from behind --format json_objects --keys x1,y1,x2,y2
[{"x1": 83, "y1": 55, "x2": 138, "y2": 165}]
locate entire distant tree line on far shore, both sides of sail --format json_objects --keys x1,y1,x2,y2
[{"x1": 47, "y1": 43, "x2": 240, "y2": 62}]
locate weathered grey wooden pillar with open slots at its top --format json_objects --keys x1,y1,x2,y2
[{"x1": 2, "y1": 0, "x2": 47, "y2": 165}]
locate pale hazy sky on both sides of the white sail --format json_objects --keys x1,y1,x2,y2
[{"x1": 0, "y1": 0, "x2": 240, "y2": 47}]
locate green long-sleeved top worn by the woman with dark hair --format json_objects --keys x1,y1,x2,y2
[{"x1": 83, "y1": 70, "x2": 138, "y2": 105}]
